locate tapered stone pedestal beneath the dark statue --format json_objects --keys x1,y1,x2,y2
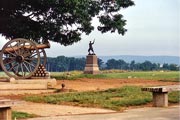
[{"x1": 84, "y1": 55, "x2": 100, "y2": 74}]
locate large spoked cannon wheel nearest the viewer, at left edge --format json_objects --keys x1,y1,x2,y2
[{"x1": 0, "y1": 38, "x2": 40, "y2": 78}]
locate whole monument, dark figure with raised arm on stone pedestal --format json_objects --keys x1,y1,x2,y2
[{"x1": 84, "y1": 40, "x2": 100, "y2": 74}]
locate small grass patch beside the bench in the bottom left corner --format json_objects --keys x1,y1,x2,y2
[{"x1": 12, "y1": 111, "x2": 36, "y2": 120}]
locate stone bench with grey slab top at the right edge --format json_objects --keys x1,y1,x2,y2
[{"x1": 141, "y1": 85, "x2": 180, "y2": 107}]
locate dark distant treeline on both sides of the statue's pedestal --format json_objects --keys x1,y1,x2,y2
[{"x1": 46, "y1": 56, "x2": 180, "y2": 72}]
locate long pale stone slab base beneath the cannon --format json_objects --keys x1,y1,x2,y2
[{"x1": 0, "y1": 78, "x2": 56, "y2": 92}]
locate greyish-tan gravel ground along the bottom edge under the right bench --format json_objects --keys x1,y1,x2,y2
[{"x1": 27, "y1": 106, "x2": 180, "y2": 120}]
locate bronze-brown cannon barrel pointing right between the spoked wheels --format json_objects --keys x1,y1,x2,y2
[{"x1": 0, "y1": 42, "x2": 50, "y2": 54}]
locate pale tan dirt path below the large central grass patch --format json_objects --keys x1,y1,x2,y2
[{"x1": 12, "y1": 101, "x2": 115, "y2": 116}]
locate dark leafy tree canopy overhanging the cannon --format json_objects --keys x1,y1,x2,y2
[{"x1": 0, "y1": 0, "x2": 134, "y2": 46}]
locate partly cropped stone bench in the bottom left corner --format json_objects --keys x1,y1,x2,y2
[{"x1": 0, "y1": 98, "x2": 13, "y2": 120}]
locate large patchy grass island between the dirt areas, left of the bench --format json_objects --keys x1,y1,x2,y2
[{"x1": 24, "y1": 86, "x2": 152, "y2": 110}]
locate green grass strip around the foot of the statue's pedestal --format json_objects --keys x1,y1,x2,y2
[{"x1": 48, "y1": 70, "x2": 180, "y2": 82}]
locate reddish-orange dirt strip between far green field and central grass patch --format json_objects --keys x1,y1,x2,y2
[{"x1": 57, "y1": 78, "x2": 177, "y2": 91}]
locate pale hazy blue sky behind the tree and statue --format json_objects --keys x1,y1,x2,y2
[{"x1": 0, "y1": 0, "x2": 180, "y2": 57}]
